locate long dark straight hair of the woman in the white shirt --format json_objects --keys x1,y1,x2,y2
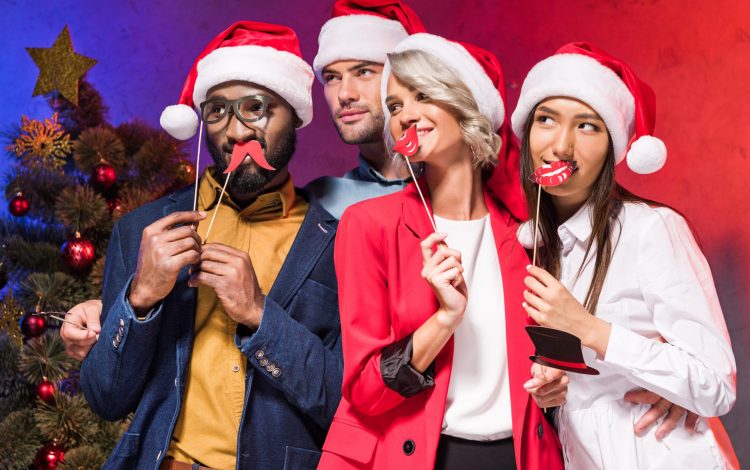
[{"x1": 521, "y1": 104, "x2": 666, "y2": 314}]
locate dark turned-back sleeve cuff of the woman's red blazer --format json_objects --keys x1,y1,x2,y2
[{"x1": 380, "y1": 335, "x2": 435, "y2": 398}]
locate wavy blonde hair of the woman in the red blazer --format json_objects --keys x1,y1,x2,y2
[{"x1": 385, "y1": 50, "x2": 503, "y2": 167}]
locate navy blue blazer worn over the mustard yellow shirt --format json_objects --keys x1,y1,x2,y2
[{"x1": 81, "y1": 187, "x2": 343, "y2": 469}]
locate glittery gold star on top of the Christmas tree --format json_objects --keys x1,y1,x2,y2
[{"x1": 26, "y1": 26, "x2": 96, "y2": 106}]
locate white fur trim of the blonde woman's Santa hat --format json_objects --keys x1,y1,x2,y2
[{"x1": 380, "y1": 33, "x2": 505, "y2": 129}]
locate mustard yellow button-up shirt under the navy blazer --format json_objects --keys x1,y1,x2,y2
[{"x1": 167, "y1": 168, "x2": 308, "y2": 469}]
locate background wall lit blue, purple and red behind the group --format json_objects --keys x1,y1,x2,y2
[{"x1": 0, "y1": 0, "x2": 750, "y2": 462}]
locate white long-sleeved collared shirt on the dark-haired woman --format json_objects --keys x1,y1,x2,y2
[{"x1": 519, "y1": 203, "x2": 736, "y2": 470}]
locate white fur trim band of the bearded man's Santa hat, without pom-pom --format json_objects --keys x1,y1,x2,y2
[{"x1": 193, "y1": 46, "x2": 314, "y2": 127}]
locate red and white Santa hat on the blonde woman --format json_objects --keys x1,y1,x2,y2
[{"x1": 380, "y1": 33, "x2": 526, "y2": 219}]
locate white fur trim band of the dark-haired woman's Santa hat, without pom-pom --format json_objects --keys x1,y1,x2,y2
[{"x1": 511, "y1": 54, "x2": 635, "y2": 163}]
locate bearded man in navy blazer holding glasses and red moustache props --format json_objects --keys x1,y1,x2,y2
[{"x1": 73, "y1": 22, "x2": 342, "y2": 469}]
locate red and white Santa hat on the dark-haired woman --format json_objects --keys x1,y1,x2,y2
[{"x1": 511, "y1": 42, "x2": 667, "y2": 174}]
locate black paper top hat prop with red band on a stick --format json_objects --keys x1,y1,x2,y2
[{"x1": 526, "y1": 326, "x2": 599, "y2": 375}]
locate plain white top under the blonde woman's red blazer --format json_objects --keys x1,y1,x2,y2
[{"x1": 435, "y1": 215, "x2": 513, "y2": 441}]
